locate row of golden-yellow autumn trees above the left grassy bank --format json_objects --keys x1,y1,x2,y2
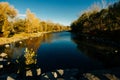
[{"x1": 0, "y1": 2, "x2": 70, "y2": 37}]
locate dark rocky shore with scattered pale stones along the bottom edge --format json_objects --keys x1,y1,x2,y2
[{"x1": 0, "y1": 68, "x2": 120, "y2": 80}]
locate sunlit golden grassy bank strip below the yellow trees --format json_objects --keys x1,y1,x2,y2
[{"x1": 0, "y1": 32, "x2": 44, "y2": 45}]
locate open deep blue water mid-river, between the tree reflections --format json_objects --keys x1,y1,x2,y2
[{"x1": 37, "y1": 32, "x2": 101, "y2": 71}]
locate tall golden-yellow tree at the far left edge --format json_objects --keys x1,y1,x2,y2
[{"x1": 0, "y1": 2, "x2": 17, "y2": 35}]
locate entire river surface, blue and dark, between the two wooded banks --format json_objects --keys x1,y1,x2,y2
[{"x1": 0, "y1": 32, "x2": 120, "y2": 76}]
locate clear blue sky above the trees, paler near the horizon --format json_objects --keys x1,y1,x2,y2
[{"x1": 0, "y1": 0, "x2": 116, "y2": 25}]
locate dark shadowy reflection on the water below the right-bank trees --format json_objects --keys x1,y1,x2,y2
[{"x1": 71, "y1": 34, "x2": 120, "y2": 68}]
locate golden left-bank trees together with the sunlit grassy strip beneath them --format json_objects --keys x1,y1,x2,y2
[{"x1": 0, "y1": 2, "x2": 71, "y2": 45}]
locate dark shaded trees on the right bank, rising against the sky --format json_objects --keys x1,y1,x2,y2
[{"x1": 71, "y1": 1, "x2": 120, "y2": 35}]
